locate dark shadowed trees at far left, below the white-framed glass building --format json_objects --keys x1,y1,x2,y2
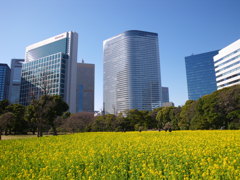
[{"x1": 0, "y1": 95, "x2": 70, "y2": 139}]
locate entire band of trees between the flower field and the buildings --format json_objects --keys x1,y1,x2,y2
[{"x1": 0, "y1": 85, "x2": 240, "y2": 137}]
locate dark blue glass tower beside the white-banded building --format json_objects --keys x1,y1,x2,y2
[{"x1": 185, "y1": 51, "x2": 218, "y2": 100}]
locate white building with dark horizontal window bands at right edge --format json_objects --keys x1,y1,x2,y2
[{"x1": 214, "y1": 39, "x2": 240, "y2": 89}]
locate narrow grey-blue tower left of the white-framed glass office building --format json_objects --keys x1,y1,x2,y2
[{"x1": 8, "y1": 59, "x2": 24, "y2": 104}]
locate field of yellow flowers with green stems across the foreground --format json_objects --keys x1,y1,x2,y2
[{"x1": 0, "y1": 131, "x2": 240, "y2": 180}]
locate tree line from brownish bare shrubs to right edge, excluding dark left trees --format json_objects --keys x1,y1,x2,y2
[{"x1": 67, "y1": 85, "x2": 240, "y2": 132}]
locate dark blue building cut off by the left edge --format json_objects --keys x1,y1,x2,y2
[{"x1": 0, "y1": 63, "x2": 11, "y2": 101}]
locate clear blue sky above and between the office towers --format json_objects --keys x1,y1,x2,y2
[{"x1": 0, "y1": 0, "x2": 240, "y2": 110}]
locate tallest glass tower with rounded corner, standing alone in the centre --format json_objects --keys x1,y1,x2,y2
[{"x1": 103, "y1": 30, "x2": 162, "y2": 114}]
